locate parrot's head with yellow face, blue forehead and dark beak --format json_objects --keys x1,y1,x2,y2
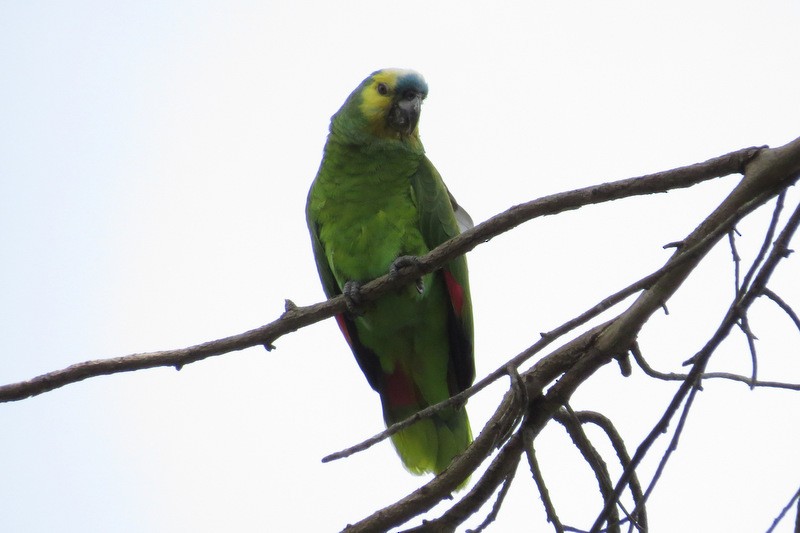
[{"x1": 331, "y1": 69, "x2": 428, "y2": 147}]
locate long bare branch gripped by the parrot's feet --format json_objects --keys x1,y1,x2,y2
[{"x1": 0, "y1": 143, "x2": 761, "y2": 402}]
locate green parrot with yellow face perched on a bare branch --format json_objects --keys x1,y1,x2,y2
[{"x1": 306, "y1": 69, "x2": 475, "y2": 474}]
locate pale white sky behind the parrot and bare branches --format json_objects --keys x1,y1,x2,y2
[{"x1": 0, "y1": 1, "x2": 800, "y2": 532}]
